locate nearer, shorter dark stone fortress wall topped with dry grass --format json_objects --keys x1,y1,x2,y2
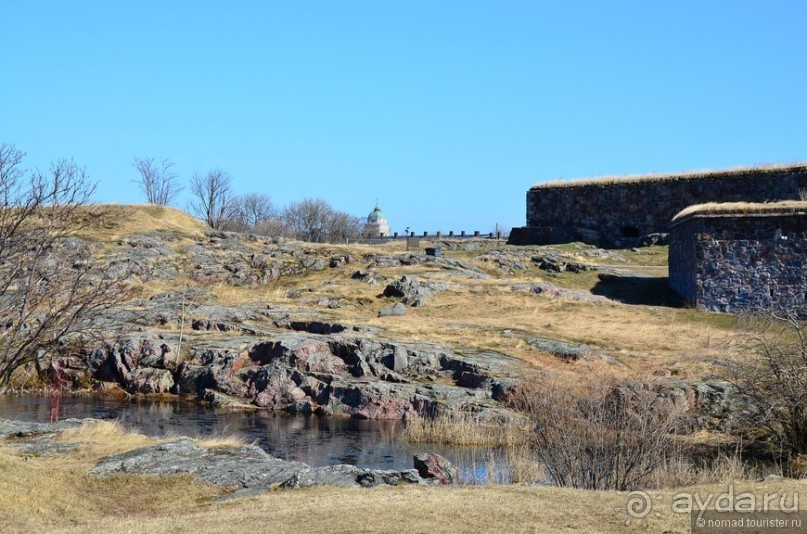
[{"x1": 669, "y1": 203, "x2": 807, "y2": 317}]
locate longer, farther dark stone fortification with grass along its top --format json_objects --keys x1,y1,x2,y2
[{"x1": 510, "y1": 163, "x2": 807, "y2": 247}]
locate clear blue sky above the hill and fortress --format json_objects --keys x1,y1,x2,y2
[{"x1": 0, "y1": 0, "x2": 807, "y2": 232}]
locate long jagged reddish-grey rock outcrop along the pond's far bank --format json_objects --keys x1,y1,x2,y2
[{"x1": 83, "y1": 333, "x2": 520, "y2": 419}]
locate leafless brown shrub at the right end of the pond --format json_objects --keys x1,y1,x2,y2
[{"x1": 513, "y1": 377, "x2": 681, "y2": 491}]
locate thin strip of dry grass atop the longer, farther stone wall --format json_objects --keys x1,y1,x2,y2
[{"x1": 532, "y1": 163, "x2": 807, "y2": 190}]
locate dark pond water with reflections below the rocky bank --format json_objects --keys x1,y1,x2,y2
[{"x1": 0, "y1": 397, "x2": 509, "y2": 483}]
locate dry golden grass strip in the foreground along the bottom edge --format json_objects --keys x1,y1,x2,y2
[{"x1": 0, "y1": 466, "x2": 805, "y2": 534}]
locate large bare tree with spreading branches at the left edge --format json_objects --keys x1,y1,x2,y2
[{"x1": 0, "y1": 145, "x2": 134, "y2": 391}]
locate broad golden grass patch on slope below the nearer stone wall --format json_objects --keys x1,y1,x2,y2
[{"x1": 352, "y1": 283, "x2": 733, "y2": 372}]
